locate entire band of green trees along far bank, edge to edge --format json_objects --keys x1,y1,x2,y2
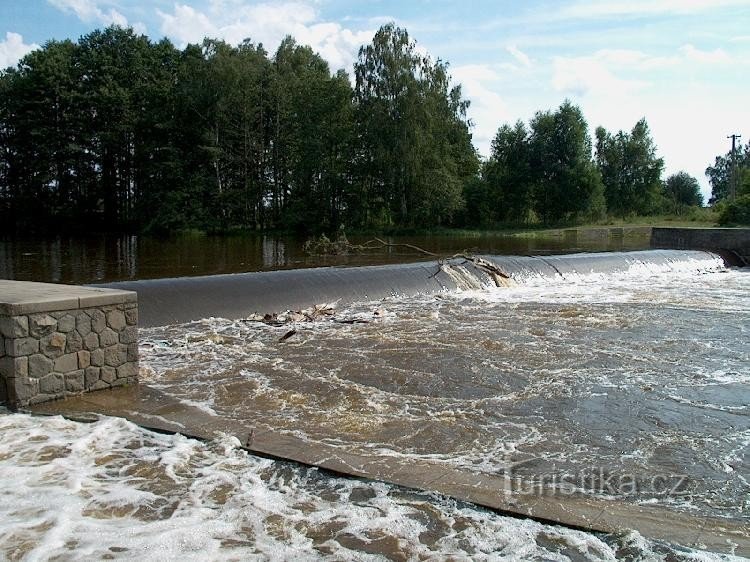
[{"x1": 0, "y1": 24, "x2": 750, "y2": 233}]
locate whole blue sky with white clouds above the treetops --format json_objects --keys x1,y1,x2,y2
[{"x1": 0, "y1": 0, "x2": 750, "y2": 196}]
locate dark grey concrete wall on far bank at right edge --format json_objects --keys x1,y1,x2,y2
[{"x1": 651, "y1": 227, "x2": 750, "y2": 265}]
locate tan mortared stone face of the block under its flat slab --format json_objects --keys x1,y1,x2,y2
[{"x1": 0, "y1": 284, "x2": 138, "y2": 408}]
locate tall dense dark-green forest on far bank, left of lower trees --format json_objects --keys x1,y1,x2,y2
[{"x1": 0, "y1": 25, "x2": 479, "y2": 231}]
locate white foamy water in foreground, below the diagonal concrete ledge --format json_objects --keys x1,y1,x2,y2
[{"x1": 0, "y1": 413, "x2": 735, "y2": 561}]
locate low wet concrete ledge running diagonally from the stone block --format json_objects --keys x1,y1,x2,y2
[{"x1": 32, "y1": 385, "x2": 750, "y2": 556}]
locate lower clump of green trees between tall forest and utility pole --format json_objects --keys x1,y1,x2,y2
[{"x1": 466, "y1": 106, "x2": 703, "y2": 224}]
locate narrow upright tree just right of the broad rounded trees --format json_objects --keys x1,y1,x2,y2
[{"x1": 596, "y1": 119, "x2": 664, "y2": 217}]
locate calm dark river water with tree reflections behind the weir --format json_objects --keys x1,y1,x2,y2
[{"x1": 0, "y1": 228, "x2": 650, "y2": 284}]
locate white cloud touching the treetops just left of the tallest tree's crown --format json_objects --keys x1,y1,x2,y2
[{"x1": 158, "y1": 0, "x2": 373, "y2": 69}]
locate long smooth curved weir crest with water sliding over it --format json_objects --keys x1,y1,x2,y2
[{"x1": 104, "y1": 250, "x2": 720, "y2": 327}]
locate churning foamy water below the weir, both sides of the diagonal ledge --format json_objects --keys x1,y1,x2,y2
[{"x1": 0, "y1": 230, "x2": 750, "y2": 560}]
